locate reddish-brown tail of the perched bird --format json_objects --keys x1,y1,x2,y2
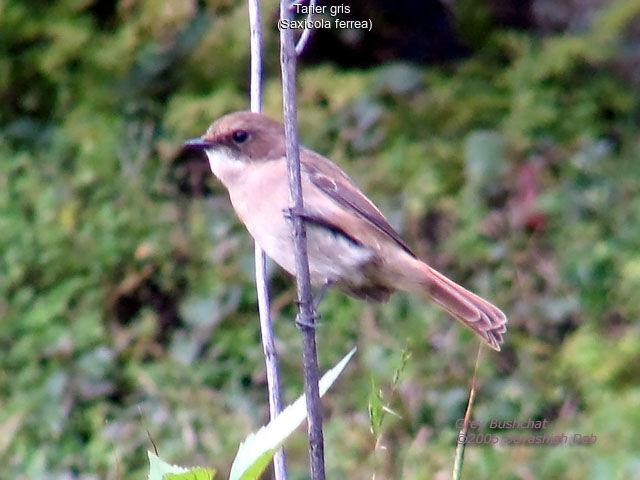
[{"x1": 396, "y1": 257, "x2": 507, "y2": 351}]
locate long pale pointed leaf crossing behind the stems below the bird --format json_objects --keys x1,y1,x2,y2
[{"x1": 229, "y1": 348, "x2": 356, "y2": 480}]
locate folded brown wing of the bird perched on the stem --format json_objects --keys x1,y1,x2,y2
[{"x1": 301, "y1": 149, "x2": 415, "y2": 257}]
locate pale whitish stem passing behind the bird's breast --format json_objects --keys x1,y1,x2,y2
[{"x1": 248, "y1": 0, "x2": 287, "y2": 480}]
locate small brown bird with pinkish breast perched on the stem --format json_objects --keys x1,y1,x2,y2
[{"x1": 184, "y1": 111, "x2": 507, "y2": 351}]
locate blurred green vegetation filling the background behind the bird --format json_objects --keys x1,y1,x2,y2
[{"x1": 0, "y1": 0, "x2": 640, "y2": 479}]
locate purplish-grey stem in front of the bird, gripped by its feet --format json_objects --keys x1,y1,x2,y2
[{"x1": 280, "y1": 0, "x2": 325, "y2": 480}]
